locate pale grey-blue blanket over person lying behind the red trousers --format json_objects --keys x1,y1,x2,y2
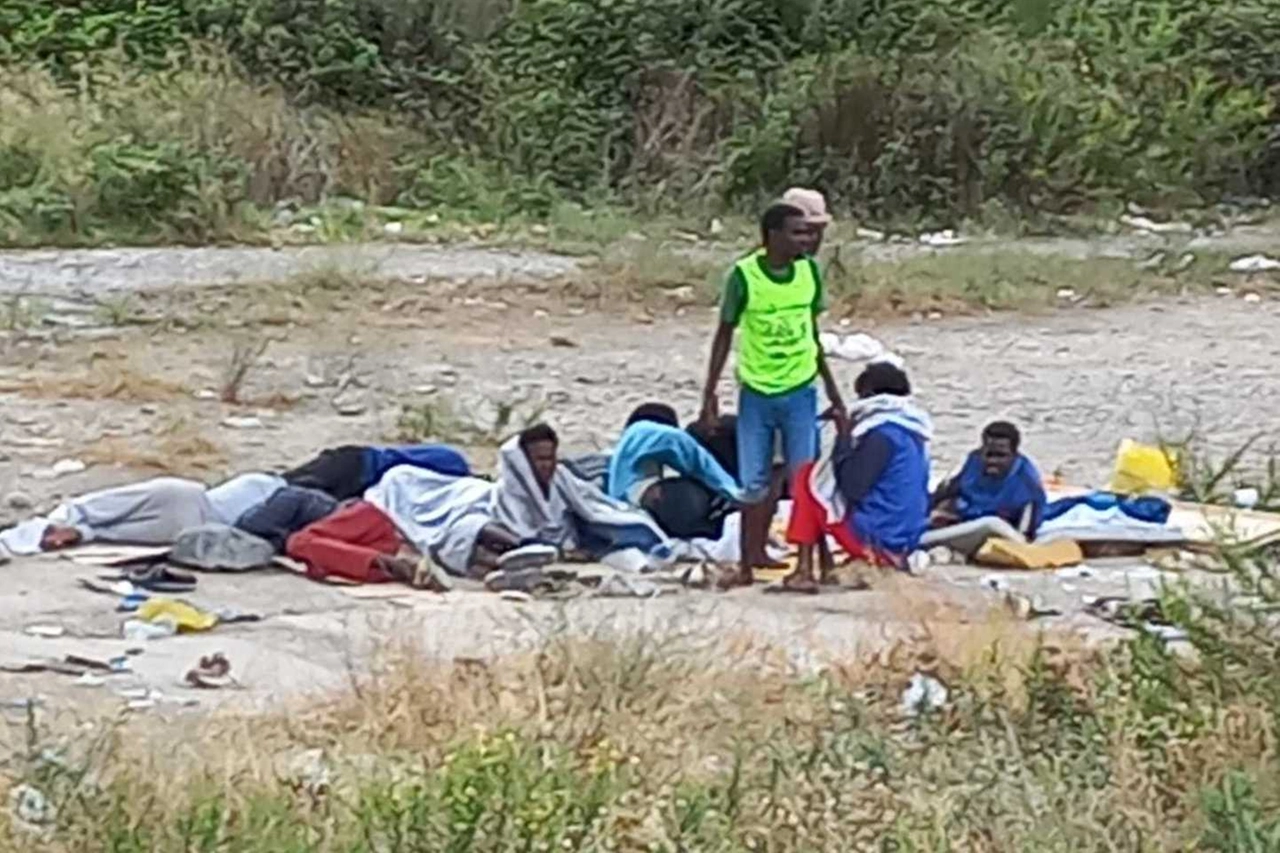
[{"x1": 365, "y1": 465, "x2": 495, "y2": 575}]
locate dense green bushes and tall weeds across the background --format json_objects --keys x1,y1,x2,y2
[{"x1": 0, "y1": 0, "x2": 1280, "y2": 243}]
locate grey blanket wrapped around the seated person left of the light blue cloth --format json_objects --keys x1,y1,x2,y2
[{"x1": 492, "y1": 438, "x2": 672, "y2": 558}]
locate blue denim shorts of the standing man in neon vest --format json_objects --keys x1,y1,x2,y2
[{"x1": 737, "y1": 384, "x2": 818, "y2": 503}]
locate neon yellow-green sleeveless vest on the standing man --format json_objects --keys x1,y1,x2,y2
[{"x1": 737, "y1": 252, "x2": 818, "y2": 394}]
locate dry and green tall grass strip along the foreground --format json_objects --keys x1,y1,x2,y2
[{"x1": 0, "y1": 568, "x2": 1280, "y2": 853}]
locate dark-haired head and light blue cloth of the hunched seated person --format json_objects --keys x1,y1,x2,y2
[{"x1": 605, "y1": 403, "x2": 742, "y2": 506}]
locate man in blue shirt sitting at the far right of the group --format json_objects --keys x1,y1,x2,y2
[{"x1": 922, "y1": 420, "x2": 1047, "y2": 557}]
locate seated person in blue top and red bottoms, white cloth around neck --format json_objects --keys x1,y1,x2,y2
[{"x1": 781, "y1": 362, "x2": 933, "y2": 593}]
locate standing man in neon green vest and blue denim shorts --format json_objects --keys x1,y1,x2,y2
[{"x1": 701, "y1": 204, "x2": 844, "y2": 585}]
